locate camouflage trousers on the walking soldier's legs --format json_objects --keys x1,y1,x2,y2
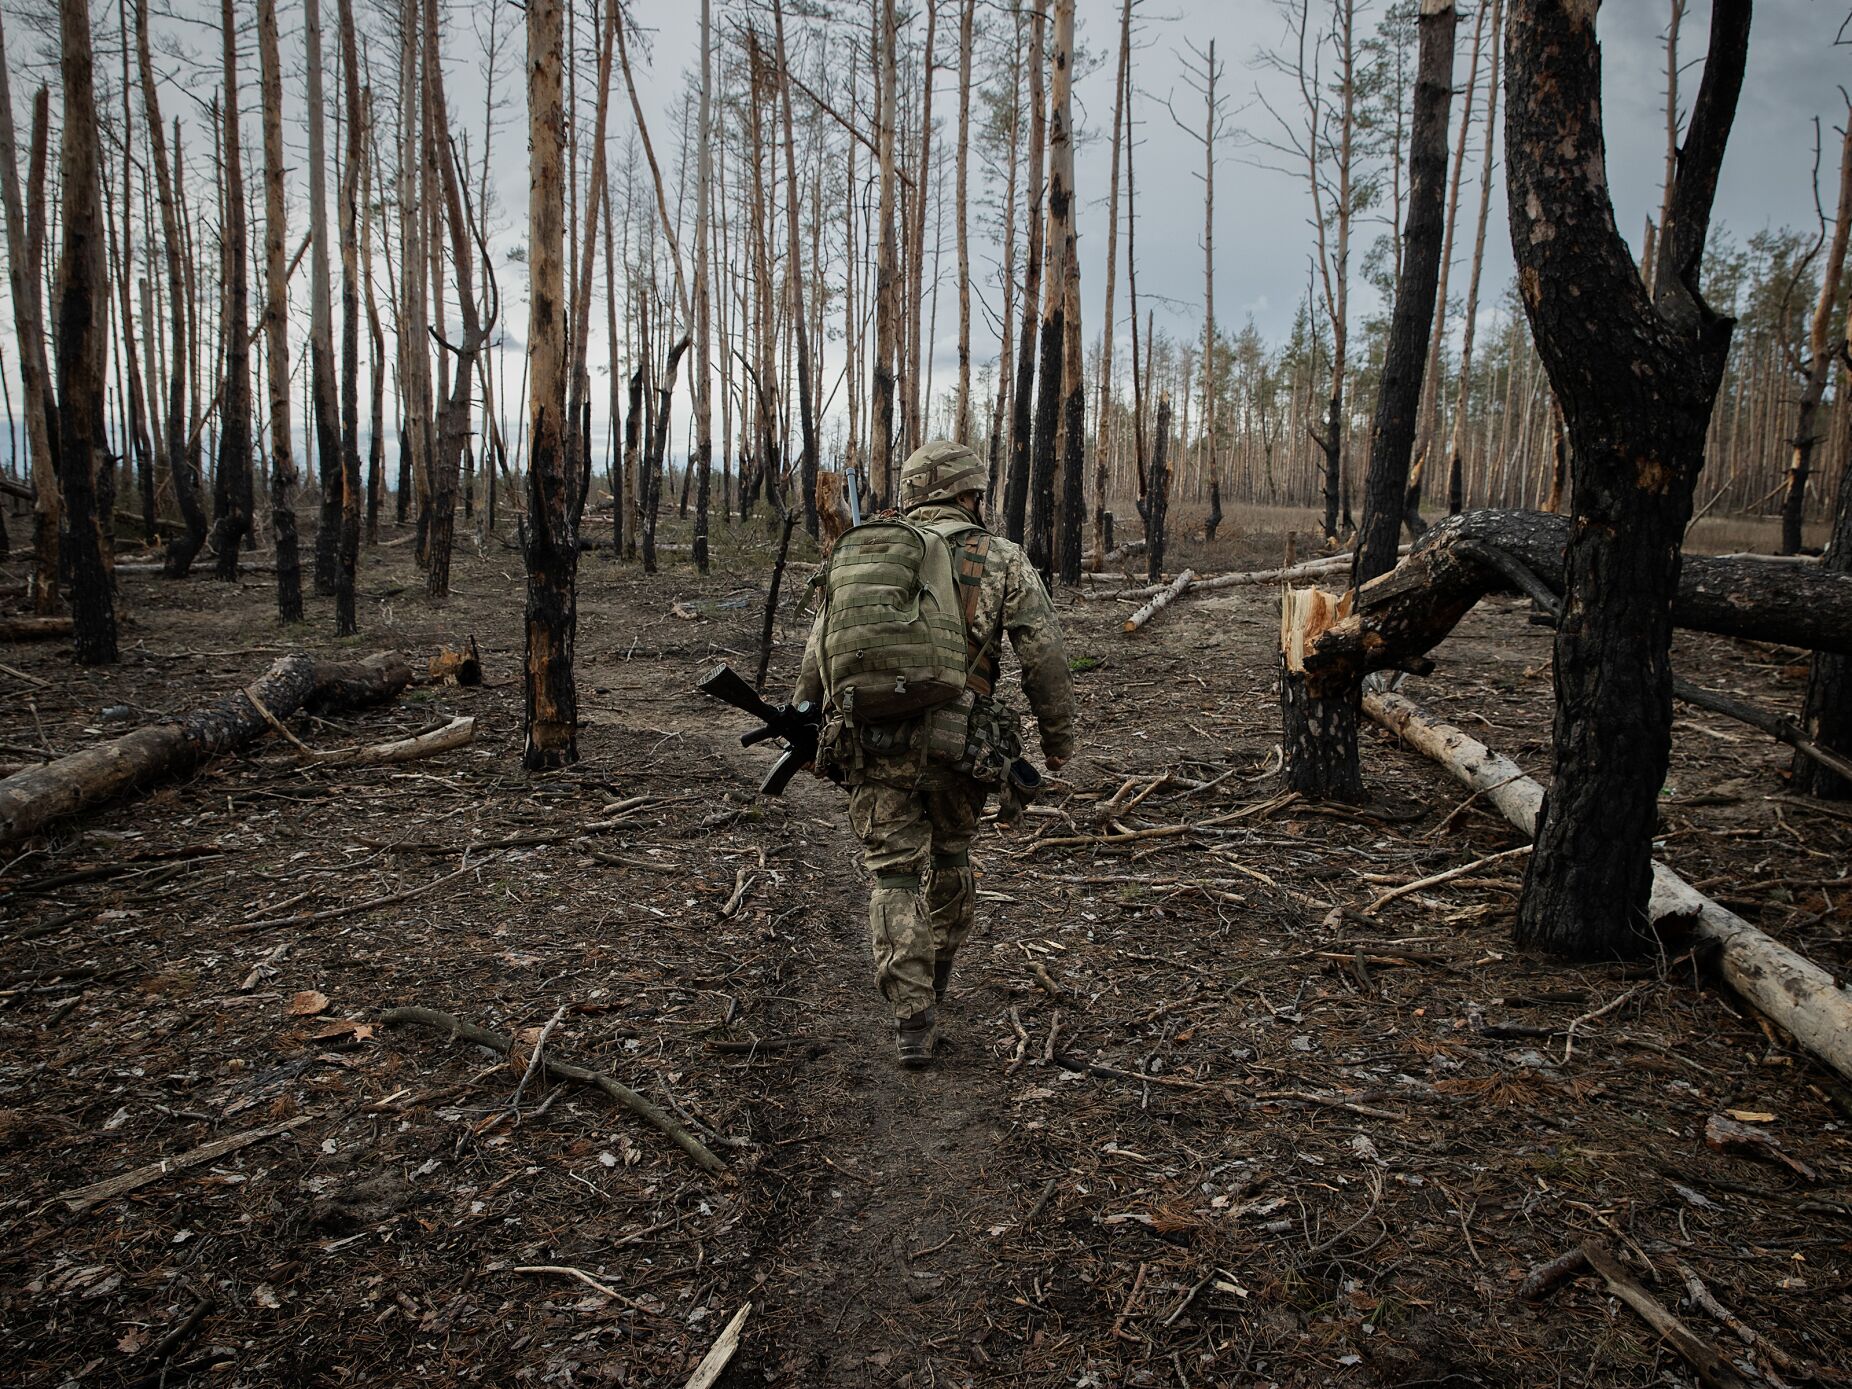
[{"x1": 848, "y1": 767, "x2": 987, "y2": 1019}]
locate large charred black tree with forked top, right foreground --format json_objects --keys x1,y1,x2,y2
[{"x1": 1506, "y1": 0, "x2": 1750, "y2": 957}]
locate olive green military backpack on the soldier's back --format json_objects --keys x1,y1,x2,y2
[{"x1": 819, "y1": 517, "x2": 970, "y2": 724}]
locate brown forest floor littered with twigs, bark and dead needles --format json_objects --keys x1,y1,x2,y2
[{"x1": 0, "y1": 507, "x2": 1852, "y2": 1389}]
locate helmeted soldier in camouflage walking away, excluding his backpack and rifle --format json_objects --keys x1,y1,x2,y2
[{"x1": 793, "y1": 439, "x2": 1074, "y2": 1069}]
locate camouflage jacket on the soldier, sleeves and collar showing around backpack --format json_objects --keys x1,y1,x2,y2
[{"x1": 793, "y1": 502, "x2": 1074, "y2": 777}]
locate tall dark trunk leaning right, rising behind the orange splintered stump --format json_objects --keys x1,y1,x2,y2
[{"x1": 1352, "y1": 0, "x2": 1458, "y2": 585}]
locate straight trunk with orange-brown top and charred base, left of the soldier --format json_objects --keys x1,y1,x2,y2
[{"x1": 522, "y1": 0, "x2": 578, "y2": 772}]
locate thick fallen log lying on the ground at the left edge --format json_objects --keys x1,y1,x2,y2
[{"x1": 0, "y1": 652, "x2": 411, "y2": 845}]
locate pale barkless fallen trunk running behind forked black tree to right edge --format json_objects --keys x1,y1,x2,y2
[{"x1": 1363, "y1": 692, "x2": 1852, "y2": 1080}]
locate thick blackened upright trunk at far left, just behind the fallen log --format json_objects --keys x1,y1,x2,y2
[{"x1": 56, "y1": 0, "x2": 117, "y2": 665}]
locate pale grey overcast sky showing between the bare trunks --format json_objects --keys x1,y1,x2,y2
[{"x1": 6, "y1": 0, "x2": 1852, "y2": 470}]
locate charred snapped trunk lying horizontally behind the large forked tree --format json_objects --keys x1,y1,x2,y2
[{"x1": 1306, "y1": 511, "x2": 1852, "y2": 689}]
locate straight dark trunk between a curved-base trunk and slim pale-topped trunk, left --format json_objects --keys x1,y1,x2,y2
[{"x1": 213, "y1": 0, "x2": 252, "y2": 582}]
